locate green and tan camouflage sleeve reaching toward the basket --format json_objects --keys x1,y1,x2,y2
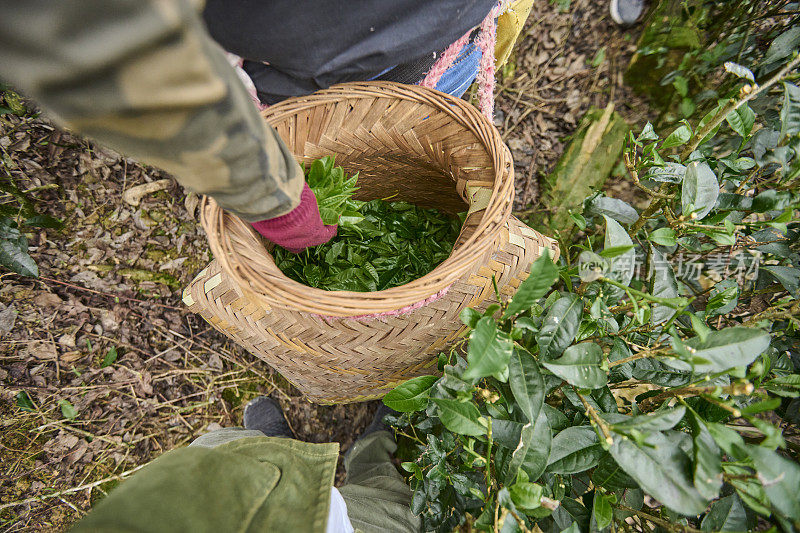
[{"x1": 0, "y1": 0, "x2": 303, "y2": 222}]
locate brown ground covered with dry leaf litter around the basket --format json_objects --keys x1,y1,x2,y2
[{"x1": 0, "y1": 0, "x2": 647, "y2": 531}]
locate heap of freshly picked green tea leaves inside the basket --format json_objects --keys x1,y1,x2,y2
[{"x1": 273, "y1": 157, "x2": 462, "y2": 292}]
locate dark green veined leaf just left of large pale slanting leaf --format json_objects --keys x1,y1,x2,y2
[{"x1": 547, "y1": 426, "x2": 606, "y2": 475}]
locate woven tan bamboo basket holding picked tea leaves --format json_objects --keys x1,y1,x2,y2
[{"x1": 183, "y1": 82, "x2": 559, "y2": 403}]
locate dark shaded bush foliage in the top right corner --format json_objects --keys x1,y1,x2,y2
[{"x1": 627, "y1": 0, "x2": 800, "y2": 122}]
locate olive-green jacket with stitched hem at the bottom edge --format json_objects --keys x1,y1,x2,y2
[{"x1": 73, "y1": 437, "x2": 339, "y2": 533}]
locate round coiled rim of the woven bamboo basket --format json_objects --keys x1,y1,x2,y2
[{"x1": 200, "y1": 81, "x2": 514, "y2": 317}]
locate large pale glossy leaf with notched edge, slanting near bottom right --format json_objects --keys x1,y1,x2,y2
[{"x1": 610, "y1": 433, "x2": 707, "y2": 516}]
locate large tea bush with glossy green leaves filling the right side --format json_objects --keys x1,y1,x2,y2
[{"x1": 384, "y1": 53, "x2": 800, "y2": 533}]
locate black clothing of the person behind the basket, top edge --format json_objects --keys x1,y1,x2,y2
[{"x1": 203, "y1": 0, "x2": 496, "y2": 104}]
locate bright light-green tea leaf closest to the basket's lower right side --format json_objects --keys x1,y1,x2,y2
[{"x1": 462, "y1": 317, "x2": 514, "y2": 381}]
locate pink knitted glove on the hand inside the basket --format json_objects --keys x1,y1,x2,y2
[{"x1": 253, "y1": 183, "x2": 338, "y2": 254}]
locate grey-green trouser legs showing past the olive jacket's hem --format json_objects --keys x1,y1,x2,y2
[{"x1": 190, "y1": 428, "x2": 421, "y2": 533}]
